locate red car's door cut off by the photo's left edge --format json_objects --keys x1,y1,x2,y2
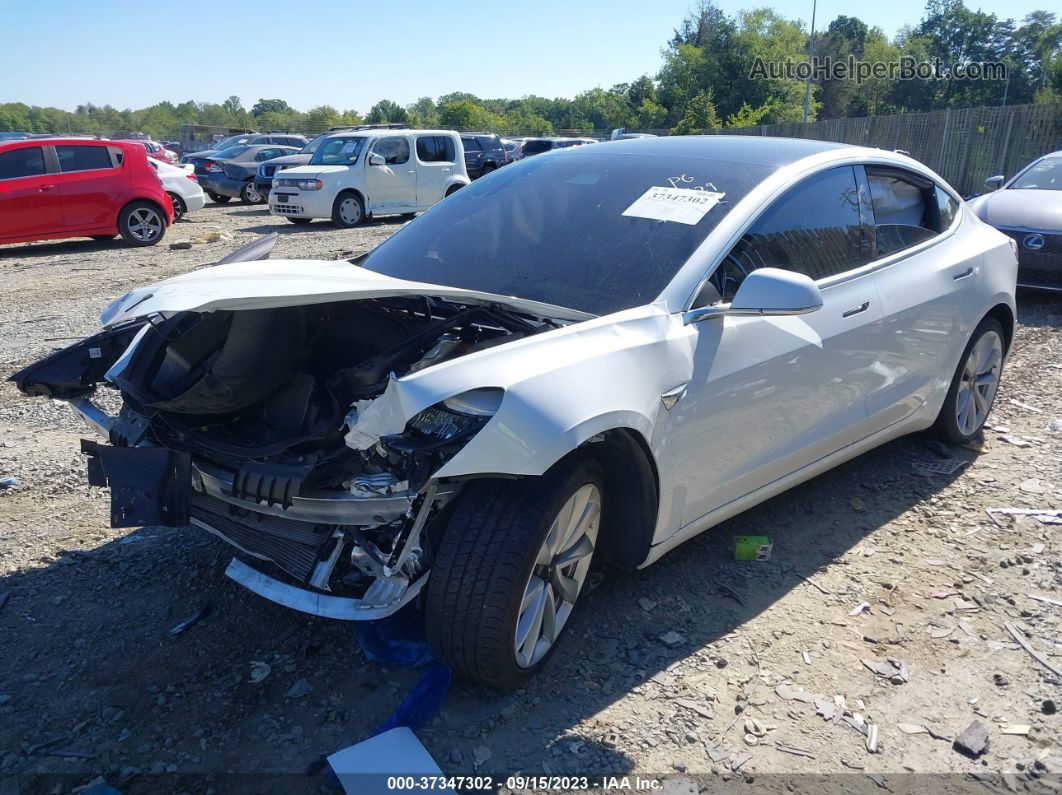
[{"x1": 0, "y1": 146, "x2": 63, "y2": 240}]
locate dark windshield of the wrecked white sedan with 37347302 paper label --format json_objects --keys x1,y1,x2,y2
[{"x1": 363, "y1": 146, "x2": 775, "y2": 314}]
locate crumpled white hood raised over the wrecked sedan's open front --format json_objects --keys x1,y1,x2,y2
[{"x1": 100, "y1": 260, "x2": 594, "y2": 327}]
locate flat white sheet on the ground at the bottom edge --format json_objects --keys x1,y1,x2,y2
[{"x1": 328, "y1": 726, "x2": 453, "y2": 795}]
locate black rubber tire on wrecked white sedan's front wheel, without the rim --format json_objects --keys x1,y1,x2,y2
[{"x1": 425, "y1": 459, "x2": 607, "y2": 688}]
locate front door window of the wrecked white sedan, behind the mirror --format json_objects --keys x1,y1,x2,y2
[{"x1": 709, "y1": 166, "x2": 863, "y2": 301}]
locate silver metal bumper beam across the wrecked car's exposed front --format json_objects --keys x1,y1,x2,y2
[{"x1": 192, "y1": 461, "x2": 456, "y2": 528}]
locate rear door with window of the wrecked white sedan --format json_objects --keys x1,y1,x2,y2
[{"x1": 860, "y1": 166, "x2": 982, "y2": 429}]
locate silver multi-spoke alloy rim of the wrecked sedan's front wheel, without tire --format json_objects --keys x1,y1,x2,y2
[{"x1": 514, "y1": 483, "x2": 601, "y2": 668}]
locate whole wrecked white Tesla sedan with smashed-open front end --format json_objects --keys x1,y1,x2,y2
[{"x1": 13, "y1": 136, "x2": 1016, "y2": 686}]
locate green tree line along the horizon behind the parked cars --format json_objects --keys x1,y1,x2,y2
[{"x1": 0, "y1": 0, "x2": 1062, "y2": 138}]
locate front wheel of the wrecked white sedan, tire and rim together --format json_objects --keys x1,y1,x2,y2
[{"x1": 425, "y1": 460, "x2": 605, "y2": 688}]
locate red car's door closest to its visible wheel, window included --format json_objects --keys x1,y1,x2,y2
[{"x1": 55, "y1": 143, "x2": 129, "y2": 231}]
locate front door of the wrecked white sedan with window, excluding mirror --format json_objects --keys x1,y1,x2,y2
[{"x1": 664, "y1": 167, "x2": 883, "y2": 525}]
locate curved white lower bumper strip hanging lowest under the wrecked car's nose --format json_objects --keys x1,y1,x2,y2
[{"x1": 225, "y1": 557, "x2": 428, "y2": 621}]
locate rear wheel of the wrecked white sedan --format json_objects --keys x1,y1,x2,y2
[{"x1": 933, "y1": 317, "x2": 1004, "y2": 445}]
